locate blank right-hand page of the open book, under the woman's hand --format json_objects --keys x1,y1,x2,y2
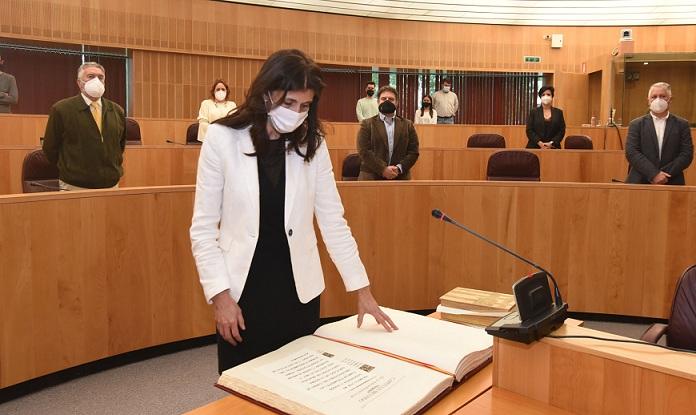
[{"x1": 314, "y1": 307, "x2": 493, "y2": 380}]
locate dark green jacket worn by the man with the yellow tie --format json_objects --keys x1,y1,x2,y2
[{"x1": 43, "y1": 95, "x2": 126, "y2": 189}]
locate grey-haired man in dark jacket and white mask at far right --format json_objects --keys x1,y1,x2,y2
[{"x1": 626, "y1": 82, "x2": 694, "y2": 185}]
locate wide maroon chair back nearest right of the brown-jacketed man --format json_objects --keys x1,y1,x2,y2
[{"x1": 486, "y1": 150, "x2": 541, "y2": 182}]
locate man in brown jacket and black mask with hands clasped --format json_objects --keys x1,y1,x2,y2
[{"x1": 358, "y1": 86, "x2": 418, "y2": 180}]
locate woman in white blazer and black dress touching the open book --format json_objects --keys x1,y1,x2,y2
[{"x1": 191, "y1": 49, "x2": 396, "y2": 372}]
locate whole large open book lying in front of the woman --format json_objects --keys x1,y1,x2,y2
[{"x1": 218, "y1": 308, "x2": 493, "y2": 415}]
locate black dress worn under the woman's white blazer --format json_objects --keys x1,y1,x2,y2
[{"x1": 218, "y1": 139, "x2": 319, "y2": 372}]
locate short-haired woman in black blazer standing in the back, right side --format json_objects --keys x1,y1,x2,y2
[{"x1": 527, "y1": 86, "x2": 565, "y2": 148}]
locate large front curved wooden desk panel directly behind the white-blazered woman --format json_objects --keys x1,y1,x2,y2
[{"x1": 0, "y1": 181, "x2": 696, "y2": 388}]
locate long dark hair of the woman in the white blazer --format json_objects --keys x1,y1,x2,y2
[{"x1": 215, "y1": 49, "x2": 324, "y2": 162}]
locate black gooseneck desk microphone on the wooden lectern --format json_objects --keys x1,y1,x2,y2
[{"x1": 432, "y1": 209, "x2": 568, "y2": 344}]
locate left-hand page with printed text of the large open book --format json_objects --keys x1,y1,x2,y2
[{"x1": 218, "y1": 336, "x2": 453, "y2": 415}]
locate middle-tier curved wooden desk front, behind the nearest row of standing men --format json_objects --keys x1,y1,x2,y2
[{"x1": 8, "y1": 144, "x2": 696, "y2": 194}]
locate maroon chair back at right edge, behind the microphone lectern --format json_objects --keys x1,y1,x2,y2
[{"x1": 667, "y1": 265, "x2": 696, "y2": 350}]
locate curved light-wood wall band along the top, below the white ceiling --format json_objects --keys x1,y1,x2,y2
[{"x1": 0, "y1": 0, "x2": 696, "y2": 72}]
